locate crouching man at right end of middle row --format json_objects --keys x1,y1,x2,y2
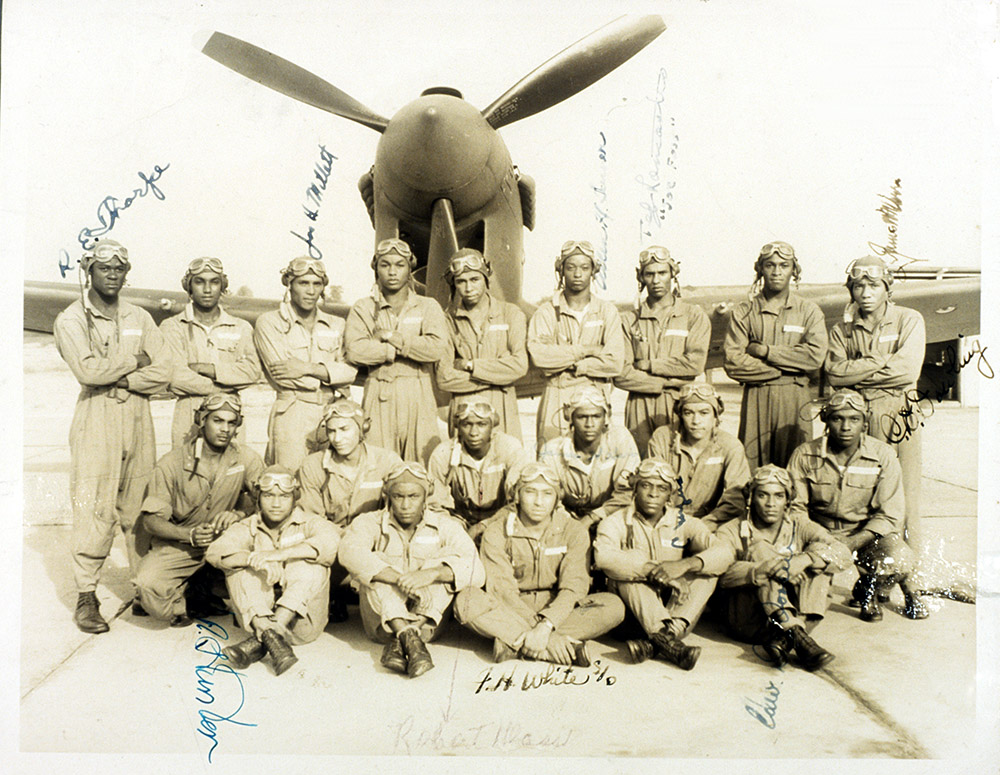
[{"x1": 788, "y1": 389, "x2": 929, "y2": 622}]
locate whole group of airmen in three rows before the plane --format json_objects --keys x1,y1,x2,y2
[{"x1": 55, "y1": 239, "x2": 928, "y2": 677}]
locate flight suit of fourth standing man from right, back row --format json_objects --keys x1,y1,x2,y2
[{"x1": 528, "y1": 291, "x2": 625, "y2": 450}]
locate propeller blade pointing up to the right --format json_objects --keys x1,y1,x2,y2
[{"x1": 483, "y1": 15, "x2": 667, "y2": 129}]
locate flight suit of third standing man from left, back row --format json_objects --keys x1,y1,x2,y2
[{"x1": 253, "y1": 301, "x2": 357, "y2": 471}]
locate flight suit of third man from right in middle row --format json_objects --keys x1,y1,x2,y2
[{"x1": 538, "y1": 425, "x2": 640, "y2": 522}]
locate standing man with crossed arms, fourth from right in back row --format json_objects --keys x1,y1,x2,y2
[{"x1": 528, "y1": 240, "x2": 625, "y2": 450}]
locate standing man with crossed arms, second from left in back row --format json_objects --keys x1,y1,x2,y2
[{"x1": 160, "y1": 258, "x2": 261, "y2": 449}]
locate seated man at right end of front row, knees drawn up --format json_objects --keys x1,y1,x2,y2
[{"x1": 715, "y1": 463, "x2": 851, "y2": 670}]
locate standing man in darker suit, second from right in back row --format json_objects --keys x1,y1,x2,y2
[{"x1": 723, "y1": 242, "x2": 827, "y2": 471}]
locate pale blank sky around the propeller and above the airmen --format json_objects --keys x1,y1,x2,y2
[{"x1": 0, "y1": 0, "x2": 996, "y2": 301}]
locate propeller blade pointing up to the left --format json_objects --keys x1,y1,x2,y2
[{"x1": 201, "y1": 32, "x2": 389, "y2": 132}]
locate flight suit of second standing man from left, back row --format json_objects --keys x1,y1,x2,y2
[{"x1": 160, "y1": 302, "x2": 261, "y2": 449}]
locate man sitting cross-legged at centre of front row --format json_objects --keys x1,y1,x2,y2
[{"x1": 455, "y1": 463, "x2": 625, "y2": 667}]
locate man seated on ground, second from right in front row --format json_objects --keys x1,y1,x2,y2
[{"x1": 594, "y1": 458, "x2": 732, "y2": 670}]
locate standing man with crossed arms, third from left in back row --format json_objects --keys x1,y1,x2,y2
[{"x1": 253, "y1": 256, "x2": 357, "y2": 471}]
